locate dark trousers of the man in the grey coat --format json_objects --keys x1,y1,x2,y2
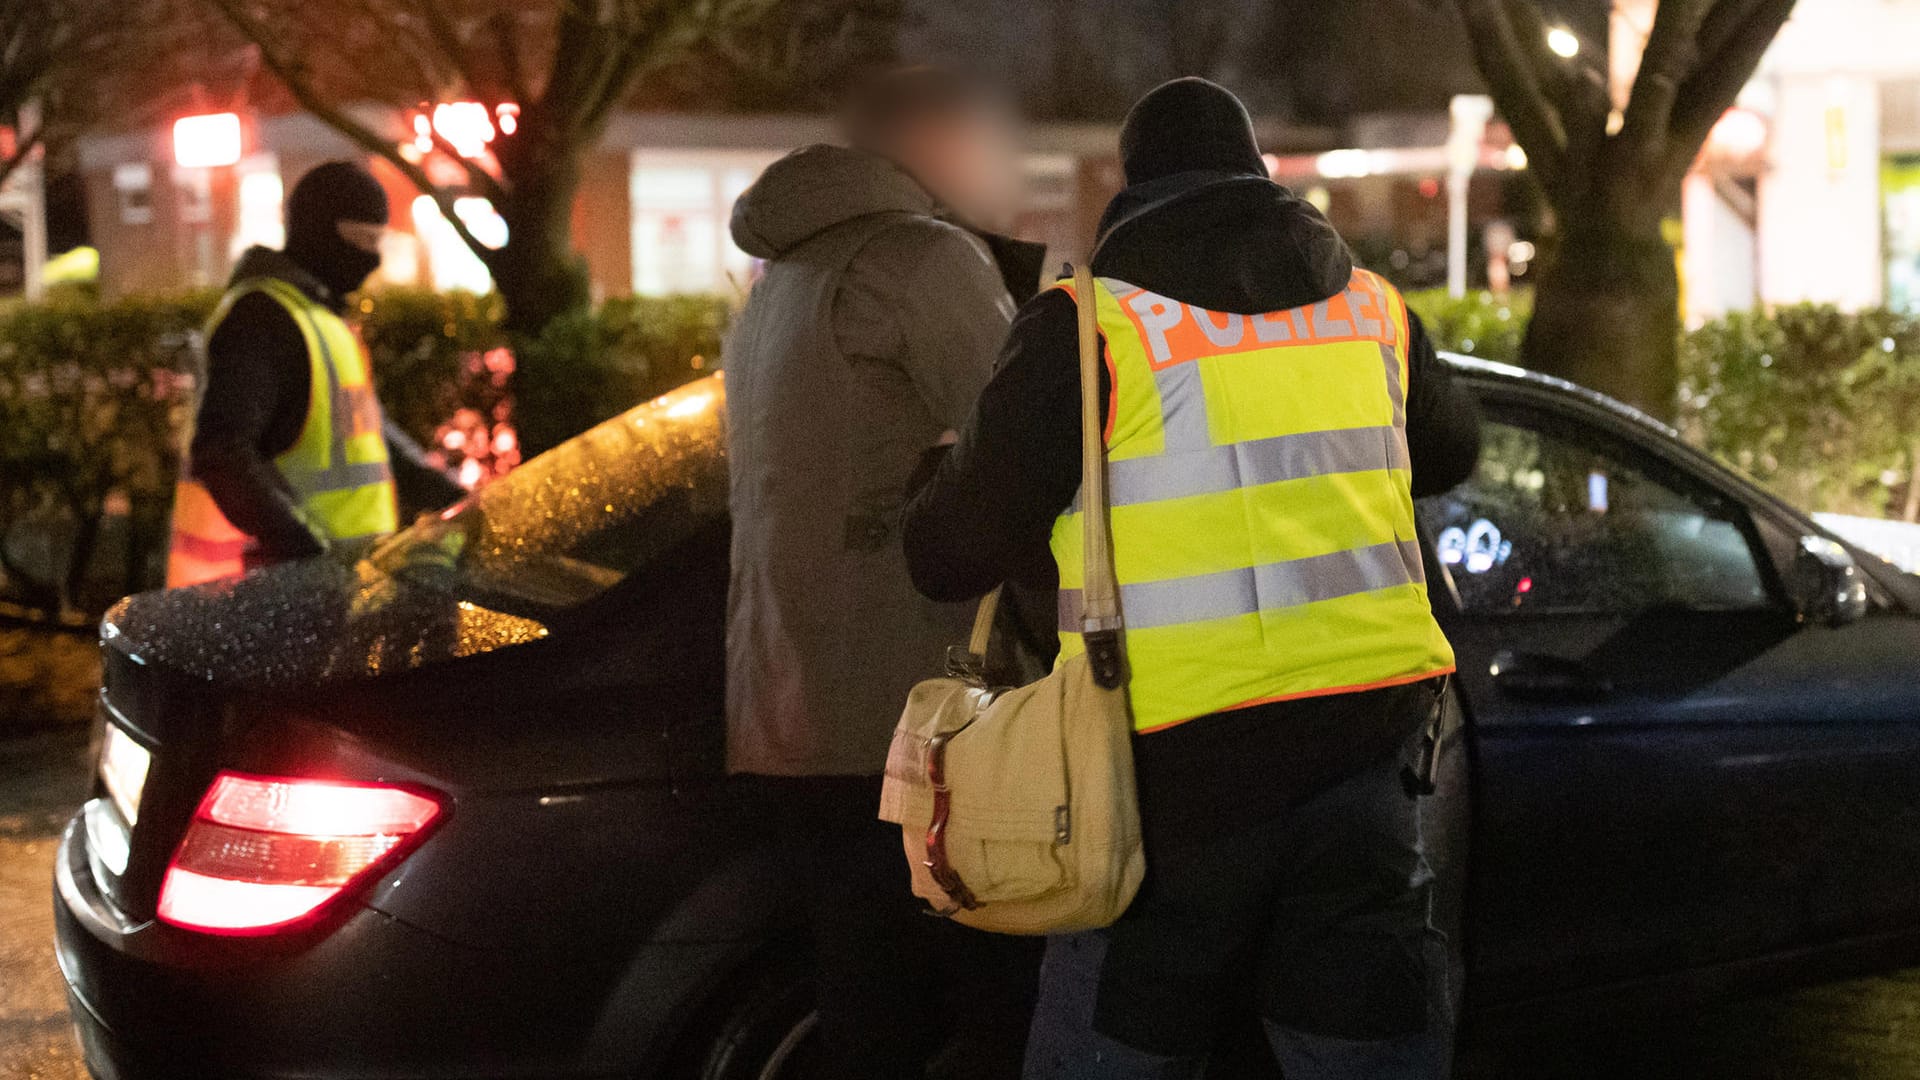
[{"x1": 739, "y1": 776, "x2": 1041, "y2": 1080}]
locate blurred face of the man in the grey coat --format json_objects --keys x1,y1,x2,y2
[{"x1": 897, "y1": 108, "x2": 1025, "y2": 233}]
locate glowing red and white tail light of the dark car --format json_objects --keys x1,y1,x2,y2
[{"x1": 159, "y1": 773, "x2": 442, "y2": 934}]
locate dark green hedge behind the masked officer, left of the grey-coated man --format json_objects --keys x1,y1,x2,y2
[{"x1": 0, "y1": 290, "x2": 728, "y2": 613}]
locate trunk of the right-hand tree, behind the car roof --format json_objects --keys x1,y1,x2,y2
[{"x1": 1521, "y1": 213, "x2": 1680, "y2": 419}]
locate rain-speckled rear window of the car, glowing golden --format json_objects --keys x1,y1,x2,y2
[{"x1": 369, "y1": 377, "x2": 726, "y2": 609}]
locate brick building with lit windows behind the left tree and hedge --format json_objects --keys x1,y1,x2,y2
[{"x1": 81, "y1": 111, "x2": 1325, "y2": 298}]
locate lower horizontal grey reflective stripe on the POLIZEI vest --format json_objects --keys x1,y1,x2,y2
[{"x1": 1060, "y1": 540, "x2": 1425, "y2": 632}]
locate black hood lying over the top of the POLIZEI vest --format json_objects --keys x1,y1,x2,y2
[{"x1": 1092, "y1": 171, "x2": 1354, "y2": 315}]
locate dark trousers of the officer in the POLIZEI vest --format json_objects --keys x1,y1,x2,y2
[{"x1": 1025, "y1": 714, "x2": 1452, "y2": 1080}]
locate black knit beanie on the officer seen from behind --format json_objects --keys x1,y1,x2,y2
[{"x1": 1119, "y1": 79, "x2": 1267, "y2": 184}]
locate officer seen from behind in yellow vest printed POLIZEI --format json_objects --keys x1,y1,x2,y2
[{"x1": 904, "y1": 79, "x2": 1478, "y2": 1080}]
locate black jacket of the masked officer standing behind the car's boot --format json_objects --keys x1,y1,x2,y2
[{"x1": 188, "y1": 248, "x2": 467, "y2": 563}]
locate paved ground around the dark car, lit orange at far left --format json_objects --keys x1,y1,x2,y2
[{"x1": 0, "y1": 730, "x2": 1920, "y2": 1080}]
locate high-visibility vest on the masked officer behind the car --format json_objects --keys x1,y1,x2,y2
[{"x1": 167, "y1": 279, "x2": 399, "y2": 588}]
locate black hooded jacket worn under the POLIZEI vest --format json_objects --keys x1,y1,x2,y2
[{"x1": 904, "y1": 173, "x2": 1478, "y2": 834}]
